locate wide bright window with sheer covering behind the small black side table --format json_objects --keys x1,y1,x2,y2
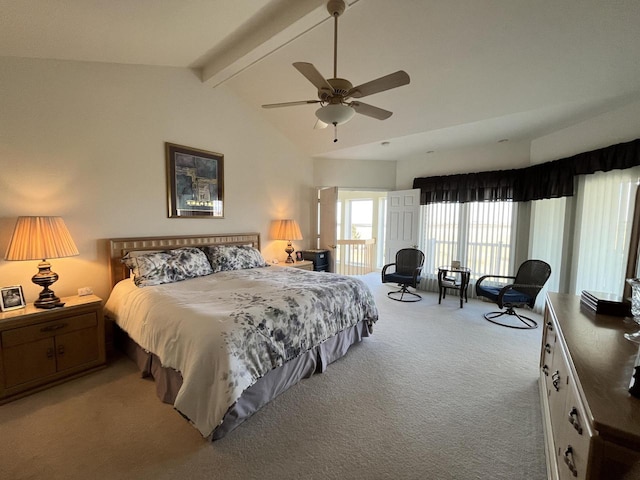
[{"x1": 421, "y1": 202, "x2": 517, "y2": 279}]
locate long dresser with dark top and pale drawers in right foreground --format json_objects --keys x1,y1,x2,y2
[{"x1": 539, "y1": 293, "x2": 640, "y2": 480}]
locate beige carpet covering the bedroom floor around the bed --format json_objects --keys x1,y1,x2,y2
[{"x1": 0, "y1": 275, "x2": 546, "y2": 480}]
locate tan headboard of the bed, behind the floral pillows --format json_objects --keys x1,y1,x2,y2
[{"x1": 109, "y1": 233, "x2": 260, "y2": 288}]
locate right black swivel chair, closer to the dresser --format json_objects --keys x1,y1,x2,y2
[{"x1": 476, "y1": 260, "x2": 551, "y2": 329}]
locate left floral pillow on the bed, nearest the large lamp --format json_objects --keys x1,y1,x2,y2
[{"x1": 122, "y1": 247, "x2": 213, "y2": 287}]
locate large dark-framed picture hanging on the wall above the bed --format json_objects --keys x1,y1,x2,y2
[{"x1": 165, "y1": 142, "x2": 224, "y2": 218}]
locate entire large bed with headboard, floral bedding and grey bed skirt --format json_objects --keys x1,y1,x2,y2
[{"x1": 105, "y1": 233, "x2": 378, "y2": 440}]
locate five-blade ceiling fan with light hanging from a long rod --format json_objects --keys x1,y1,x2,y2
[{"x1": 262, "y1": 0, "x2": 410, "y2": 142}]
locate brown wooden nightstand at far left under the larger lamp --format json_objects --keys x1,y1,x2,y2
[{"x1": 0, "y1": 295, "x2": 106, "y2": 404}]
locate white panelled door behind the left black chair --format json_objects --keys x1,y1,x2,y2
[{"x1": 384, "y1": 188, "x2": 420, "y2": 263}]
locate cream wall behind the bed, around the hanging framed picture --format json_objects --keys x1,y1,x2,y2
[{"x1": 0, "y1": 57, "x2": 314, "y2": 301}]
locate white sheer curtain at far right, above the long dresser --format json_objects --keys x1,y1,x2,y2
[{"x1": 572, "y1": 167, "x2": 640, "y2": 295}]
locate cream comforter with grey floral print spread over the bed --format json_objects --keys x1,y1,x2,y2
[{"x1": 105, "y1": 267, "x2": 378, "y2": 437}]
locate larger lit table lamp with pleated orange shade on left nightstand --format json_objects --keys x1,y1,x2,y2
[{"x1": 4, "y1": 217, "x2": 80, "y2": 308}]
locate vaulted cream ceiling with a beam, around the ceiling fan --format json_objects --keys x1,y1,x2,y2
[{"x1": 5, "y1": 0, "x2": 640, "y2": 160}]
